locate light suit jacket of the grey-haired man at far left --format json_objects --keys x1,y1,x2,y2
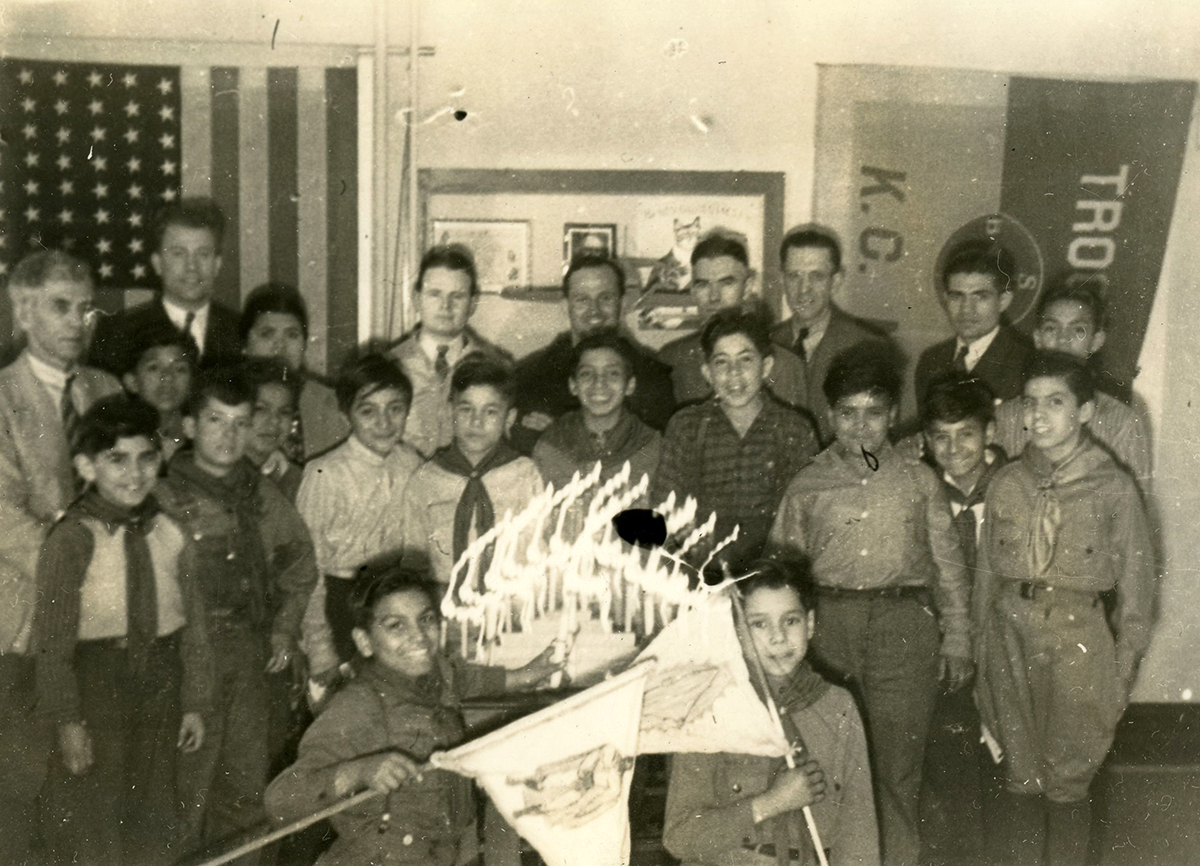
[{"x1": 0, "y1": 354, "x2": 121, "y2": 654}]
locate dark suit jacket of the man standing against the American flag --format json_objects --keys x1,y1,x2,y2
[{"x1": 88, "y1": 295, "x2": 241, "y2": 375}]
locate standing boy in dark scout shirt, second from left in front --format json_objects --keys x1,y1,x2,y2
[{"x1": 158, "y1": 368, "x2": 317, "y2": 849}]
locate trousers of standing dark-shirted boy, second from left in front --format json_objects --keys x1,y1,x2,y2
[{"x1": 179, "y1": 619, "x2": 270, "y2": 862}]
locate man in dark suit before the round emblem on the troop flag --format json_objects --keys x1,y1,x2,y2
[{"x1": 914, "y1": 241, "x2": 1033, "y2": 407}]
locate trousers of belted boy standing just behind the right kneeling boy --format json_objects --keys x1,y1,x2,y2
[{"x1": 812, "y1": 593, "x2": 941, "y2": 866}]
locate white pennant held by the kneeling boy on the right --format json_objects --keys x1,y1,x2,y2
[{"x1": 637, "y1": 593, "x2": 788, "y2": 757}]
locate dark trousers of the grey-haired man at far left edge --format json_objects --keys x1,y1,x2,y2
[{"x1": 0, "y1": 654, "x2": 50, "y2": 866}]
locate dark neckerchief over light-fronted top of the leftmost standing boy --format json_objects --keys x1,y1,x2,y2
[{"x1": 77, "y1": 488, "x2": 158, "y2": 670}]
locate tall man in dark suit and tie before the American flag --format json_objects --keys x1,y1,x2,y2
[{"x1": 89, "y1": 198, "x2": 241, "y2": 375}]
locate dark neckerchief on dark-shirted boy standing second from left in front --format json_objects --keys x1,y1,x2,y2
[{"x1": 169, "y1": 451, "x2": 270, "y2": 621}]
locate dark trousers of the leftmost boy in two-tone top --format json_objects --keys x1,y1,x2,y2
[{"x1": 43, "y1": 636, "x2": 182, "y2": 866}]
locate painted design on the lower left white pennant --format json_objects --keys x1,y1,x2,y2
[{"x1": 508, "y1": 744, "x2": 634, "y2": 830}]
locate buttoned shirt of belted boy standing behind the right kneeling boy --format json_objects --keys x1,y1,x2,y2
[{"x1": 768, "y1": 444, "x2": 971, "y2": 658}]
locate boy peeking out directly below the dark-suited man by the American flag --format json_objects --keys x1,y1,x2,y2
[{"x1": 121, "y1": 324, "x2": 198, "y2": 464}]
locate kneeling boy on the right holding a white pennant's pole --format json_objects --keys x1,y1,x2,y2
[{"x1": 662, "y1": 559, "x2": 880, "y2": 866}]
